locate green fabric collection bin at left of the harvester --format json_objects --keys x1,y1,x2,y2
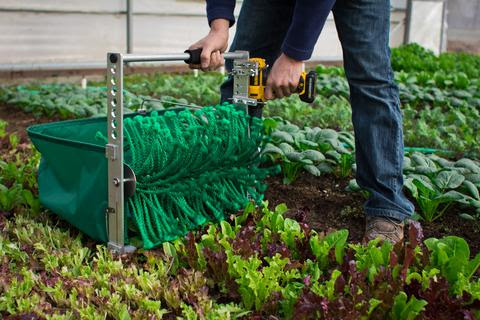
[{"x1": 27, "y1": 108, "x2": 176, "y2": 244}]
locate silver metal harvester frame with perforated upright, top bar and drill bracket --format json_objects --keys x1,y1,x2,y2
[{"x1": 105, "y1": 51, "x2": 251, "y2": 253}]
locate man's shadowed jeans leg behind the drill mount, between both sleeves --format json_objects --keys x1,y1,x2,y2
[{"x1": 220, "y1": 0, "x2": 295, "y2": 117}]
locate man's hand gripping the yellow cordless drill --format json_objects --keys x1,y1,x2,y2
[{"x1": 265, "y1": 53, "x2": 303, "y2": 100}]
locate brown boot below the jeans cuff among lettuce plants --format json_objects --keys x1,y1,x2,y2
[{"x1": 365, "y1": 217, "x2": 404, "y2": 244}]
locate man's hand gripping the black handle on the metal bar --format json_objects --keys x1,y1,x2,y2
[{"x1": 188, "y1": 19, "x2": 230, "y2": 71}]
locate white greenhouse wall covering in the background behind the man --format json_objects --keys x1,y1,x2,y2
[{"x1": 0, "y1": 0, "x2": 450, "y2": 67}]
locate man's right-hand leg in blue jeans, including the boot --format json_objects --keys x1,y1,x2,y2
[{"x1": 333, "y1": 0, "x2": 414, "y2": 237}]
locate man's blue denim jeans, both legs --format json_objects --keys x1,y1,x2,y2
[{"x1": 221, "y1": 0, "x2": 414, "y2": 220}]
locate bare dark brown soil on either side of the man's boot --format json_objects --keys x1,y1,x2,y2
[{"x1": 265, "y1": 174, "x2": 480, "y2": 254}]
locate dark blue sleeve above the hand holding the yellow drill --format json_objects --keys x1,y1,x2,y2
[{"x1": 282, "y1": 0, "x2": 335, "y2": 60}]
